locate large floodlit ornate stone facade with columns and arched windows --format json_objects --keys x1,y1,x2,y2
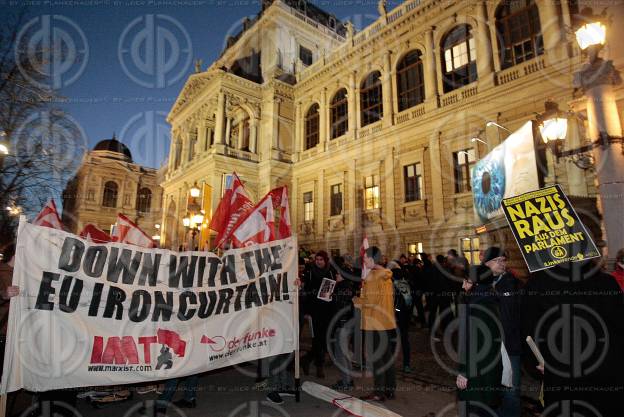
[{"x1": 162, "y1": 0, "x2": 624, "y2": 261}]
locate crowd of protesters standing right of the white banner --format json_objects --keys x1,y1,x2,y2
[{"x1": 0, "y1": 240, "x2": 624, "y2": 417}]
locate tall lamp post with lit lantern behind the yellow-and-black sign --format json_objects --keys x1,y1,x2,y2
[{"x1": 574, "y1": 9, "x2": 624, "y2": 264}]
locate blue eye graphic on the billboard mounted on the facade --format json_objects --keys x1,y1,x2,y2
[{"x1": 472, "y1": 151, "x2": 505, "y2": 222}]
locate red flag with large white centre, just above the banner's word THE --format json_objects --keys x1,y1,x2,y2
[{"x1": 230, "y1": 193, "x2": 275, "y2": 248}]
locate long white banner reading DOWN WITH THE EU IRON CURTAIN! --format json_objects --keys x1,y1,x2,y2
[{"x1": 1, "y1": 222, "x2": 298, "y2": 393}]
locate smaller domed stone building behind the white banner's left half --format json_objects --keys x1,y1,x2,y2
[{"x1": 62, "y1": 136, "x2": 162, "y2": 236}]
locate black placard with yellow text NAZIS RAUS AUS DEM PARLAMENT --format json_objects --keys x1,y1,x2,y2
[{"x1": 502, "y1": 185, "x2": 600, "y2": 272}]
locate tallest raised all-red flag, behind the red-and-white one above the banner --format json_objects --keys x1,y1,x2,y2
[{"x1": 208, "y1": 172, "x2": 254, "y2": 248}]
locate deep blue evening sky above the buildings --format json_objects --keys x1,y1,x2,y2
[{"x1": 0, "y1": 0, "x2": 390, "y2": 167}]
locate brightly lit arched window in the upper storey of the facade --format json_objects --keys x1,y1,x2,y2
[{"x1": 440, "y1": 25, "x2": 477, "y2": 93}]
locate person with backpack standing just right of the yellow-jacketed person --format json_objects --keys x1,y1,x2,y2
[{"x1": 388, "y1": 261, "x2": 414, "y2": 372}]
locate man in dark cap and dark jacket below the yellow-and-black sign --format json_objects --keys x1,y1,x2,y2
[{"x1": 479, "y1": 246, "x2": 524, "y2": 417}]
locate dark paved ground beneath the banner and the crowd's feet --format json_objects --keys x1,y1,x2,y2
[{"x1": 3, "y1": 329, "x2": 538, "y2": 417}]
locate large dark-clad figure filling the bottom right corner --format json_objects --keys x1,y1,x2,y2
[{"x1": 523, "y1": 259, "x2": 624, "y2": 417}]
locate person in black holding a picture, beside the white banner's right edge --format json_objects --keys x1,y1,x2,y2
[{"x1": 301, "y1": 250, "x2": 337, "y2": 378}]
